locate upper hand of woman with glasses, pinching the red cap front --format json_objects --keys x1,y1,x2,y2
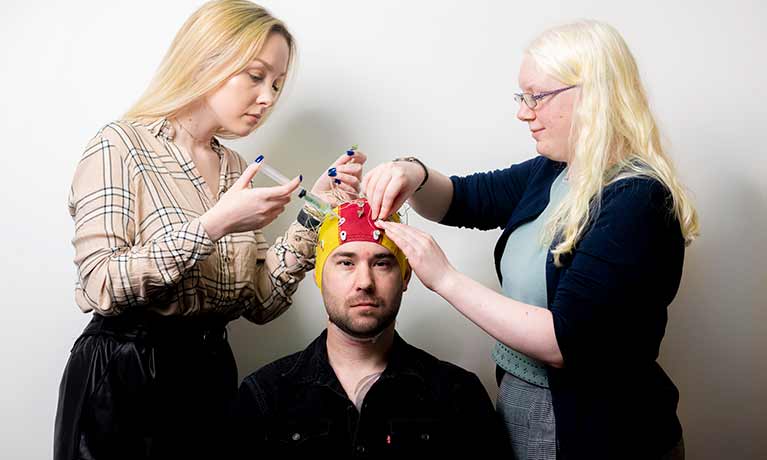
[{"x1": 362, "y1": 161, "x2": 424, "y2": 219}]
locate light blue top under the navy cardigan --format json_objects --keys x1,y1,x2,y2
[{"x1": 493, "y1": 168, "x2": 569, "y2": 388}]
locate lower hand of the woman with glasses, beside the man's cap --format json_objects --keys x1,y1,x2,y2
[{"x1": 376, "y1": 220, "x2": 457, "y2": 293}]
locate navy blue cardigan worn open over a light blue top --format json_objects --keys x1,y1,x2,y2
[{"x1": 442, "y1": 156, "x2": 684, "y2": 459}]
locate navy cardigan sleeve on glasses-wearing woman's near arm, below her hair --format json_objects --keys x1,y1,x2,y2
[{"x1": 549, "y1": 178, "x2": 684, "y2": 368}]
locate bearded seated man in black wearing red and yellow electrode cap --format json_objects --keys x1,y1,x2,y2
[{"x1": 236, "y1": 200, "x2": 504, "y2": 458}]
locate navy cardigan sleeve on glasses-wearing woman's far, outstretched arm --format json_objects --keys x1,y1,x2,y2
[{"x1": 440, "y1": 157, "x2": 543, "y2": 230}]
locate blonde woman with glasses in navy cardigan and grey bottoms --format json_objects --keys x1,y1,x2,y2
[{"x1": 362, "y1": 21, "x2": 698, "y2": 460}]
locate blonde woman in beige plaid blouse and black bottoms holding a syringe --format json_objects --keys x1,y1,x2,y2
[{"x1": 54, "y1": 0, "x2": 365, "y2": 460}]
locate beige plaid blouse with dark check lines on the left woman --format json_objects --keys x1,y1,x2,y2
[{"x1": 69, "y1": 119, "x2": 317, "y2": 323}]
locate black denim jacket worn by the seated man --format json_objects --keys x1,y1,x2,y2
[{"x1": 235, "y1": 331, "x2": 505, "y2": 458}]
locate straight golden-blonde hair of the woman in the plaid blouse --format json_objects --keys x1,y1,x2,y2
[{"x1": 123, "y1": 0, "x2": 295, "y2": 138}]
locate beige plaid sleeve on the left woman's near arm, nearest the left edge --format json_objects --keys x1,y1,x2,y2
[{"x1": 69, "y1": 130, "x2": 215, "y2": 314}]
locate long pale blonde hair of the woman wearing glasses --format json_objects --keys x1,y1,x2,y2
[{"x1": 526, "y1": 21, "x2": 699, "y2": 265}]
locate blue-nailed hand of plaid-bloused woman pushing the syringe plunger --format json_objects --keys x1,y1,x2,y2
[{"x1": 200, "y1": 163, "x2": 301, "y2": 241}]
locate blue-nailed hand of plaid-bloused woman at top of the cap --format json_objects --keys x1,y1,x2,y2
[{"x1": 311, "y1": 150, "x2": 367, "y2": 207}]
